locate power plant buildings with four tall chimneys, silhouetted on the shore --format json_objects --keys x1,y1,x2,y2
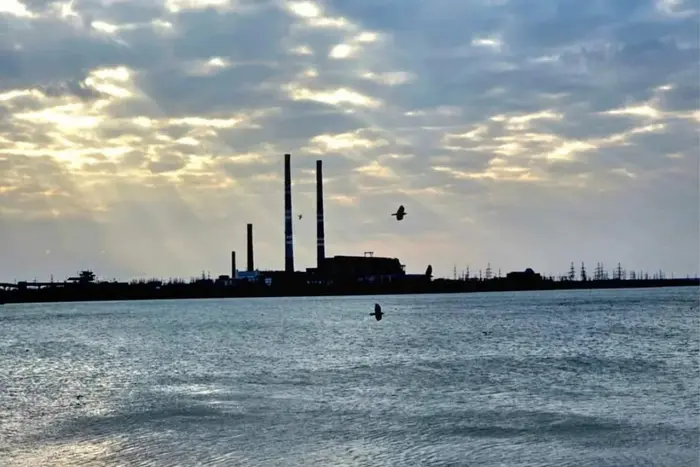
[{"x1": 230, "y1": 154, "x2": 416, "y2": 284}]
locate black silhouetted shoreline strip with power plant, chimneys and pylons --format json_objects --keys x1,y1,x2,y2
[{"x1": 0, "y1": 154, "x2": 700, "y2": 308}]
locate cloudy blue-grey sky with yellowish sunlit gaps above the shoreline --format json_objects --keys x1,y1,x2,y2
[{"x1": 0, "y1": 0, "x2": 700, "y2": 282}]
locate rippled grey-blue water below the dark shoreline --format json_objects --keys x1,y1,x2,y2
[{"x1": 0, "y1": 287, "x2": 700, "y2": 467}]
